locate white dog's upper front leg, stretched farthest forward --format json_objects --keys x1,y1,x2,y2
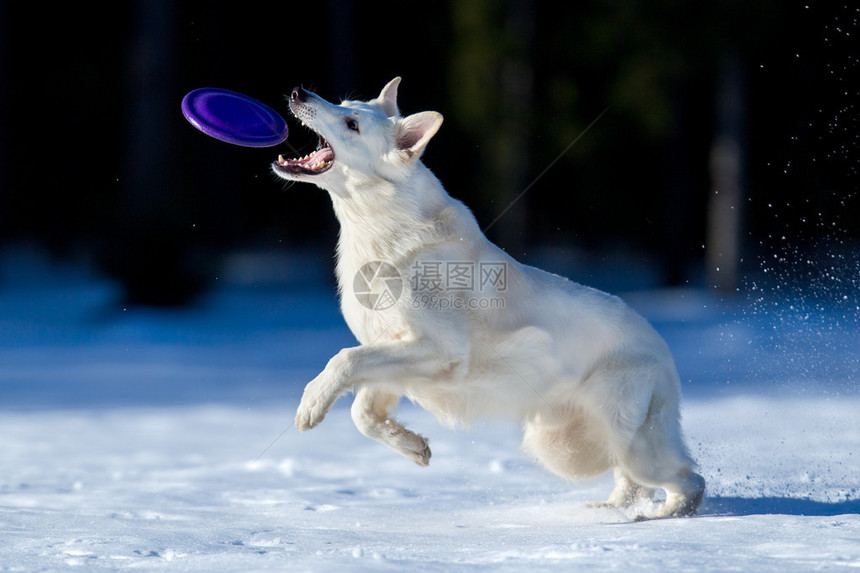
[{"x1": 296, "y1": 341, "x2": 465, "y2": 432}]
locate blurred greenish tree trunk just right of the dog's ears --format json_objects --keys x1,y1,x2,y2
[{"x1": 449, "y1": 0, "x2": 534, "y2": 256}]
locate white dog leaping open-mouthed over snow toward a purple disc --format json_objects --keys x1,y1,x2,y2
[{"x1": 272, "y1": 78, "x2": 705, "y2": 517}]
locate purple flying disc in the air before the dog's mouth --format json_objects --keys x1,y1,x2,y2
[{"x1": 182, "y1": 88, "x2": 288, "y2": 147}]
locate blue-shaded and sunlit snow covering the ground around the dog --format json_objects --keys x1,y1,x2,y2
[{"x1": 0, "y1": 249, "x2": 860, "y2": 572}]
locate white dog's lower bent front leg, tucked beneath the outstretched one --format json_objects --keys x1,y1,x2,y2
[{"x1": 351, "y1": 386, "x2": 430, "y2": 466}]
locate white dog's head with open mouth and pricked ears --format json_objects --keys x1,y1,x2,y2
[{"x1": 272, "y1": 78, "x2": 442, "y2": 193}]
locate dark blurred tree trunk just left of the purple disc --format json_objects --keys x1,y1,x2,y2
[{"x1": 105, "y1": 0, "x2": 208, "y2": 305}]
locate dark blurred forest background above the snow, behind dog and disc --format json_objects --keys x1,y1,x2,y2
[{"x1": 0, "y1": 0, "x2": 860, "y2": 305}]
